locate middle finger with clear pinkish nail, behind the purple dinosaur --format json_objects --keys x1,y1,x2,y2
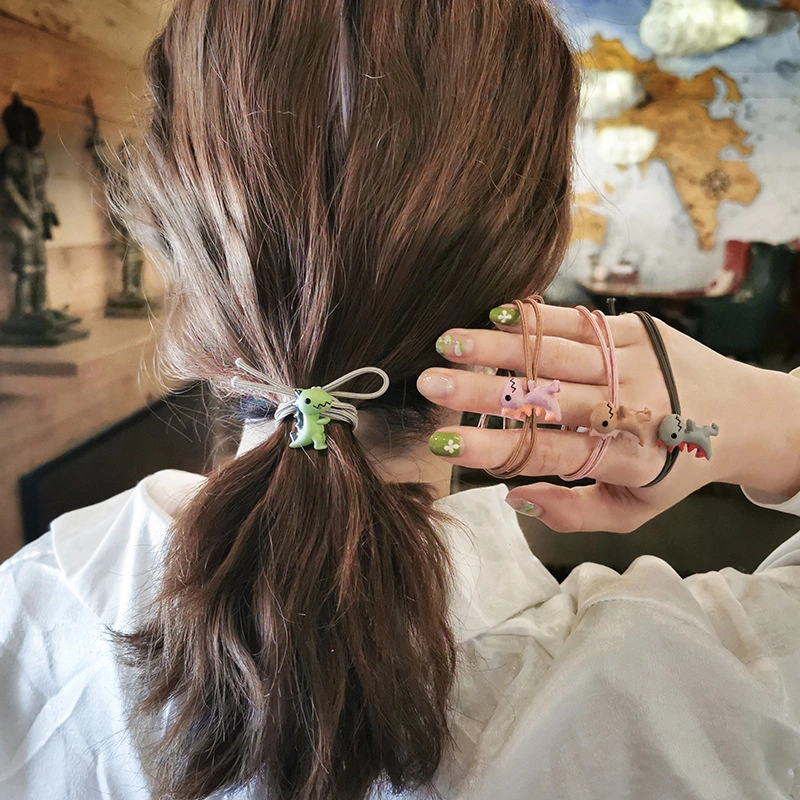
[{"x1": 417, "y1": 368, "x2": 606, "y2": 427}]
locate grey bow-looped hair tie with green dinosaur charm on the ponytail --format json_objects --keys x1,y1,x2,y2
[{"x1": 231, "y1": 358, "x2": 390, "y2": 450}]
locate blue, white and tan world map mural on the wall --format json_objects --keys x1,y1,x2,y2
[{"x1": 548, "y1": 0, "x2": 800, "y2": 294}]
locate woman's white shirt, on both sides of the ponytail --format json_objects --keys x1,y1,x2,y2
[{"x1": 0, "y1": 471, "x2": 800, "y2": 800}]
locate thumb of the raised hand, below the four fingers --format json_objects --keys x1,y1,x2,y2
[{"x1": 506, "y1": 483, "x2": 660, "y2": 533}]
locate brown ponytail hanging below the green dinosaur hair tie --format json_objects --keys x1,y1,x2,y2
[{"x1": 117, "y1": 424, "x2": 456, "y2": 800}]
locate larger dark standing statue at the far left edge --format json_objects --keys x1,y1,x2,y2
[{"x1": 0, "y1": 94, "x2": 89, "y2": 347}]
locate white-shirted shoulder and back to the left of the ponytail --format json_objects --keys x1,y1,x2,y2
[{"x1": 0, "y1": 473, "x2": 202, "y2": 800}]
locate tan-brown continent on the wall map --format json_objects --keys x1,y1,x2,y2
[{"x1": 575, "y1": 36, "x2": 760, "y2": 251}]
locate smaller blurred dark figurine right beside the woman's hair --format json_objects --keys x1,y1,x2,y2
[{"x1": 86, "y1": 97, "x2": 155, "y2": 317}]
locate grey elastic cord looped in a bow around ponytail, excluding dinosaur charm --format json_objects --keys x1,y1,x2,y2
[{"x1": 231, "y1": 358, "x2": 390, "y2": 434}]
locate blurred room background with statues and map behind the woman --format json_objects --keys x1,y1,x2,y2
[{"x1": 0, "y1": 0, "x2": 800, "y2": 579}]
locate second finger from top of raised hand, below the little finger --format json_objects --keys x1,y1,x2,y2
[{"x1": 436, "y1": 328, "x2": 608, "y2": 386}]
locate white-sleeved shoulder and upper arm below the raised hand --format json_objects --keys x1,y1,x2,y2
[{"x1": 466, "y1": 556, "x2": 800, "y2": 800}]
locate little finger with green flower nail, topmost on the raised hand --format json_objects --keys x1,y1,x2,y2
[{"x1": 490, "y1": 303, "x2": 644, "y2": 347}]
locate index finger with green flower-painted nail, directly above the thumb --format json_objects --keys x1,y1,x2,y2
[{"x1": 429, "y1": 426, "x2": 665, "y2": 486}]
